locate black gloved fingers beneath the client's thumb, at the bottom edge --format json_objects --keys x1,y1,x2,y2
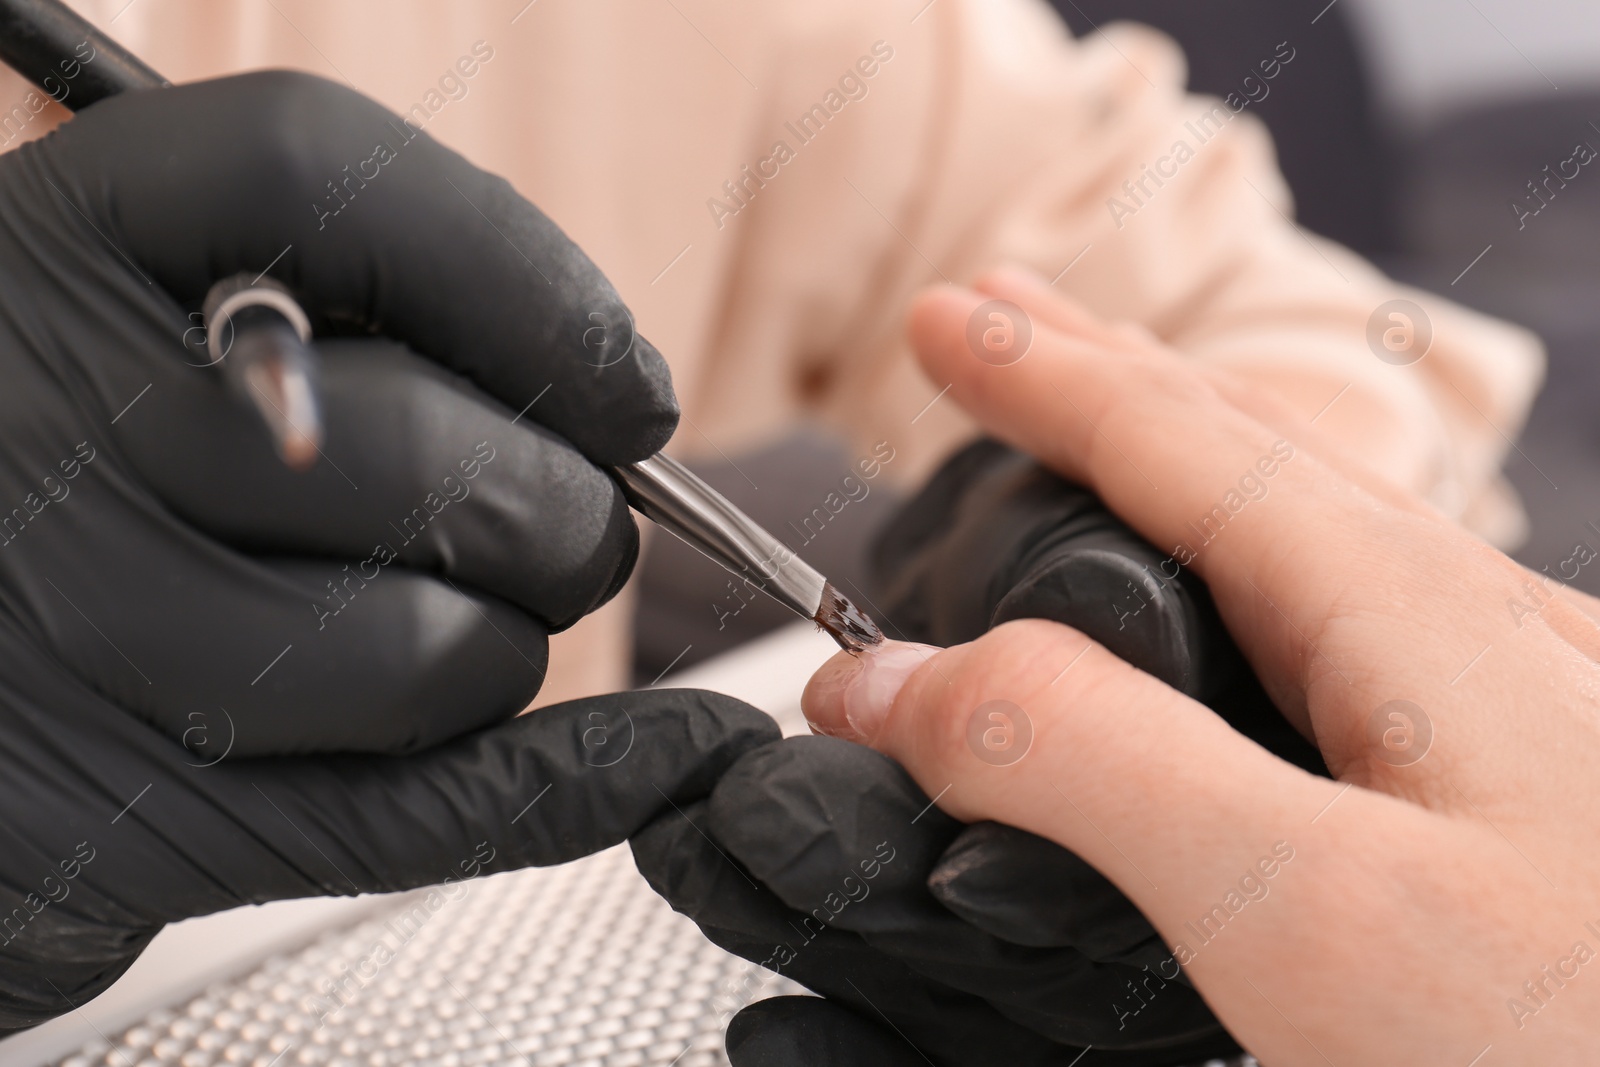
[{"x1": 632, "y1": 737, "x2": 1238, "y2": 1067}]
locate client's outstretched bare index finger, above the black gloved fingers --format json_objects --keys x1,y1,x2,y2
[{"x1": 910, "y1": 279, "x2": 1408, "y2": 595}]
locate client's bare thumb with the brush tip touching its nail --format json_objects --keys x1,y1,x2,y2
[{"x1": 803, "y1": 619, "x2": 1339, "y2": 908}]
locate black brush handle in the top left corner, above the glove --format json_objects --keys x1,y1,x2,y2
[{"x1": 0, "y1": 0, "x2": 171, "y2": 110}]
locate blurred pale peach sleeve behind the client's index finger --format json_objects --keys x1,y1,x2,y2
[{"x1": 707, "y1": 0, "x2": 1542, "y2": 539}]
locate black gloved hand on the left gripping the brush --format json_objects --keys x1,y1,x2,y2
[{"x1": 0, "y1": 74, "x2": 776, "y2": 1030}]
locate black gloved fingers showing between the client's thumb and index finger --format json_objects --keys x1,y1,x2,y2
[{"x1": 872, "y1": 440, "x2": 1328, "y2": 774}]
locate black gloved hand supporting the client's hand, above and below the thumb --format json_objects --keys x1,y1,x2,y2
[{"x1": 634, "y1": 442, "x2": 1326, "y2": 1067}]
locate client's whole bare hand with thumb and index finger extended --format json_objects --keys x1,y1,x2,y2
[{"x1": 805, "y1": 272, "x2": 1600, "y2": 1067}]
